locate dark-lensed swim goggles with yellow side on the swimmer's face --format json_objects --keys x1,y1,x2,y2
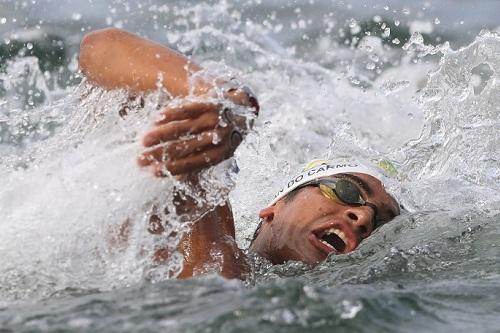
[{"x1": 294, "y1": 178, "x2": 380, "y2": 230}]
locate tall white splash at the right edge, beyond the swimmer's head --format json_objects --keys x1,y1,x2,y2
[{"x1": 394, "y1": 33, "x2": 500, "y2": 213}]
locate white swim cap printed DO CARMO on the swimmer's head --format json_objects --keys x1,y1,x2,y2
[{"x1": 268, "y1": 158, "x2": 387, "y2": 206}]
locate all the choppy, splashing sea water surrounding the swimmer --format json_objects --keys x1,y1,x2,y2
[{"x1": 0, "y1": 0, "x2": 500, "y2": 332}]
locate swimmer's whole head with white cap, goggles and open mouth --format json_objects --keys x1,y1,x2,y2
[{"x1": 250, "y1": 159, "x2": 400, "y2": 264}]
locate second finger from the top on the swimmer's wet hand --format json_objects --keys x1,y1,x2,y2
[{"x1": 143, "y1": 112, "x2": 219, "y2": 147}]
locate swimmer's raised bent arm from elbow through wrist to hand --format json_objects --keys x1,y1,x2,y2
[{"x1": 79, "y1": 28, "x2": 259, "y2": 176}]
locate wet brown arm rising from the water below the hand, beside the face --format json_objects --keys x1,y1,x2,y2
[{"x1": 106, "y1": 194, "x2": 249, "y2": 279}]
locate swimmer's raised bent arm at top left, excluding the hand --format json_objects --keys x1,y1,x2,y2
[{"x1": 79, "y1": 28, "x2": 258, "y2": 107}]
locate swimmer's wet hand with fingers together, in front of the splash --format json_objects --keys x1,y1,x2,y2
[{"x1": 138, "y1": 94, "x2": 254, "y2": 177}]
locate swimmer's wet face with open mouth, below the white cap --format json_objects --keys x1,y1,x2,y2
[{"x1": 250, "y1": 173, "x2": 399, "y2": 264}]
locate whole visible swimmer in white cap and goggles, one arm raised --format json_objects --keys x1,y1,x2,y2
[{"x1": 79, "y1": 28, "x2": 400, "y2": 278}]
